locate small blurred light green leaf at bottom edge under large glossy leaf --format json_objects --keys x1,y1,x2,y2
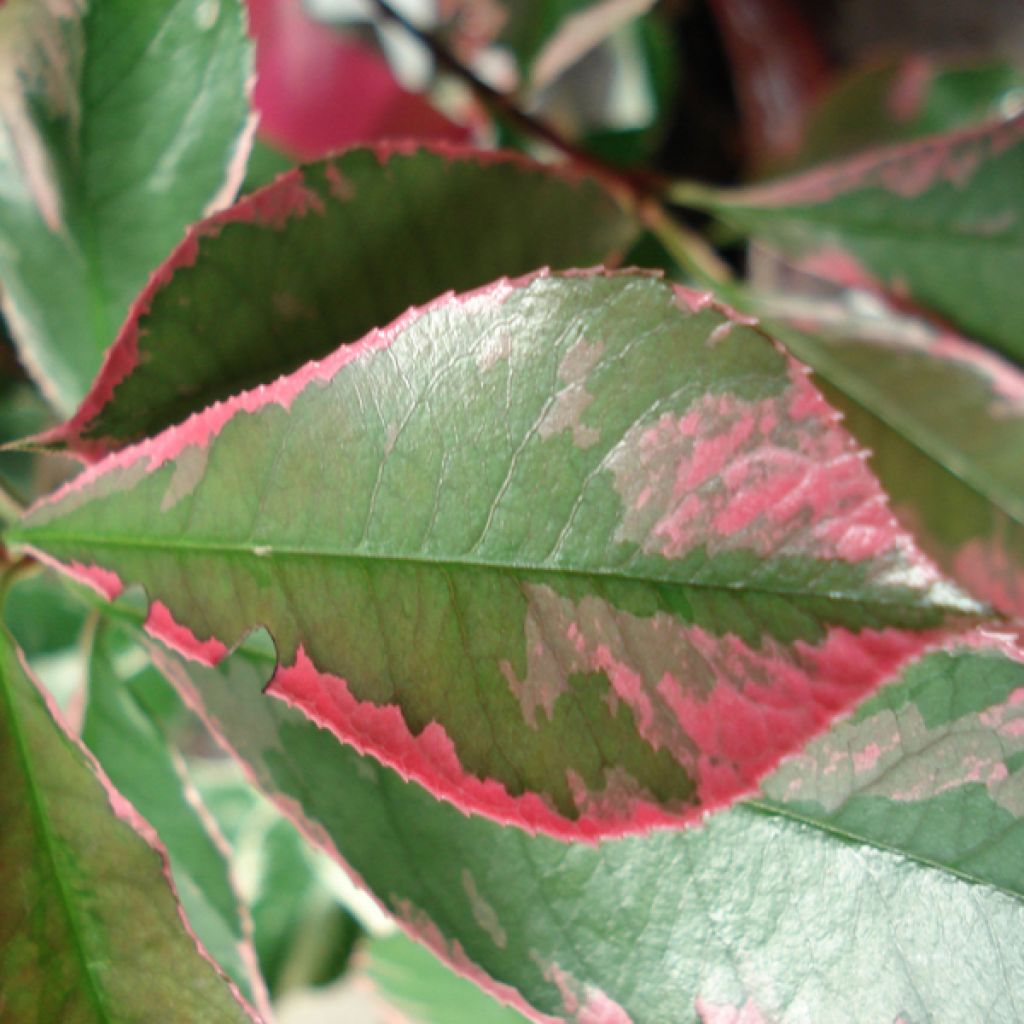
[{"x1": 367, "y1": 934, "x2": 526, "y2": 1024}]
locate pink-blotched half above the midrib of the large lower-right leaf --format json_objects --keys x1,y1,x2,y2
[{"x1": 762, "y1": 634, "x2": 1024, "y2": 899}]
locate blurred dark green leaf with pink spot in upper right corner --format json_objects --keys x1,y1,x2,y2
[{"x1": 774, "y1": 54, "x2": 1024, "y2": 171}]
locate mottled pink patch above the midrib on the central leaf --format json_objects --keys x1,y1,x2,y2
[{"x1": 607, "y1": 354, "x2": 937, "y2": 583}]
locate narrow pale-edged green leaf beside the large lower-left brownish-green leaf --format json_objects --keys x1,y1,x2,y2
[{"x1": 82, "y1": 624, "x2": 269, "y2": 1015}]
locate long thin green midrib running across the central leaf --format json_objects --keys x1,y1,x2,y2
[{"x1": 16, "y1": 529, "x2": 984, "y2": 617}]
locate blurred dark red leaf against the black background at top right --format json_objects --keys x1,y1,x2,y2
[{"x1": 711, "y1": 0, "x2": 828, "y2": 167}]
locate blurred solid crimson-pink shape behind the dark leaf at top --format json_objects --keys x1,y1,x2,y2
[{"x1": 247, "y1": 0, "x2": 469, "y2": 160}]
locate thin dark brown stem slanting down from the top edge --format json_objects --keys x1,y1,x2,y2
[{"x1": 374, "y1": 0, "x2": 668, "y2": 200}]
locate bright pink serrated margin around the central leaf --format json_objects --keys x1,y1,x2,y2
[{"x1": 14, "y1": 267, "x2": 974, "y2": 842}]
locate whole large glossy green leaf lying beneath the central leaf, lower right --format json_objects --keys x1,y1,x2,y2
[{"x1": 144, "y1": 622, "x2": 1024, "y2": 1024}]
